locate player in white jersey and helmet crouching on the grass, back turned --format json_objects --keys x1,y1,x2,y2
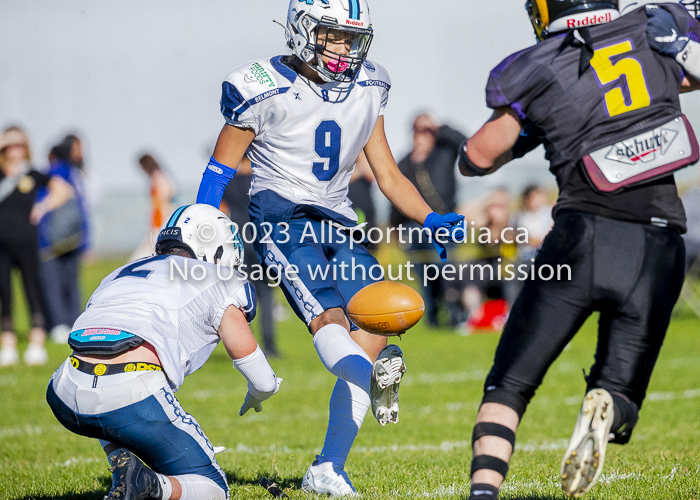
[{"x1": 46, "y1": 205, "x2": 282, "y2": 500}]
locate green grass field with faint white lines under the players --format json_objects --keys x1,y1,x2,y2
[{"x1": 0, "y1": 261, "x2": 700, "y2": 500}]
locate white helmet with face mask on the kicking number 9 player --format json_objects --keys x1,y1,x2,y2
[{"x1": 287, "y1": 0, "x2": 374, "y2": 82}]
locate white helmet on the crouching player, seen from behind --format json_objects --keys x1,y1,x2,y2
[{"x1": 156, "y1": 203, "x2": 243, "y2": 268}]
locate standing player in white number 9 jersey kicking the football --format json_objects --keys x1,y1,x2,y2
[{"x1": 197, "y1": 0, "x2": 464, "y2": 495}]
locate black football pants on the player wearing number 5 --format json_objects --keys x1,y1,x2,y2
[{"x1": 485, "y1": 210, "x2": 685, "y2": 407}]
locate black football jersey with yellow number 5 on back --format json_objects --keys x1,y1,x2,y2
[{"x1": 486, "y1": 4, "x2": 700, "y2": 231}]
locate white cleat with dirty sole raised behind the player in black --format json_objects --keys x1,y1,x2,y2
[{"x1": 561, "y1": 389, "x2": 613, "y2": 498}]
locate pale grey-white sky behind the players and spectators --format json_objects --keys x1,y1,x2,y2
[{"x1": 0, "y1": 0, "x2": 700, "y2": 250}]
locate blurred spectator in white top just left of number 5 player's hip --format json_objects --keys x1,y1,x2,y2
[{"x1": 514, "y1": 184, "x2": 554, "y2": 261}]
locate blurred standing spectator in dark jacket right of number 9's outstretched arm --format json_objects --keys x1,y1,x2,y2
[{"x1": 391, "y1": 113, "x2": 466, "y2": 326}]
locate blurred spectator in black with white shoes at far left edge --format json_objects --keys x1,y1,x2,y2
[{"x1": 0, "y1": 127, "x2": 49, "y2": 366}]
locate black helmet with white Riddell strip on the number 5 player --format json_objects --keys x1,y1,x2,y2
[{"x1": 525, "y1": 0, "x2": 620, "y2": 42}]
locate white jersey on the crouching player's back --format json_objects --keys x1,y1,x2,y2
[{"x1": 73, "y1": 255, "x2": 256, "y2": 390}]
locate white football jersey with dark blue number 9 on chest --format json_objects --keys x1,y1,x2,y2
[{"x1": 221, "y1": 56, "x2": 391, "y2": 221}]
